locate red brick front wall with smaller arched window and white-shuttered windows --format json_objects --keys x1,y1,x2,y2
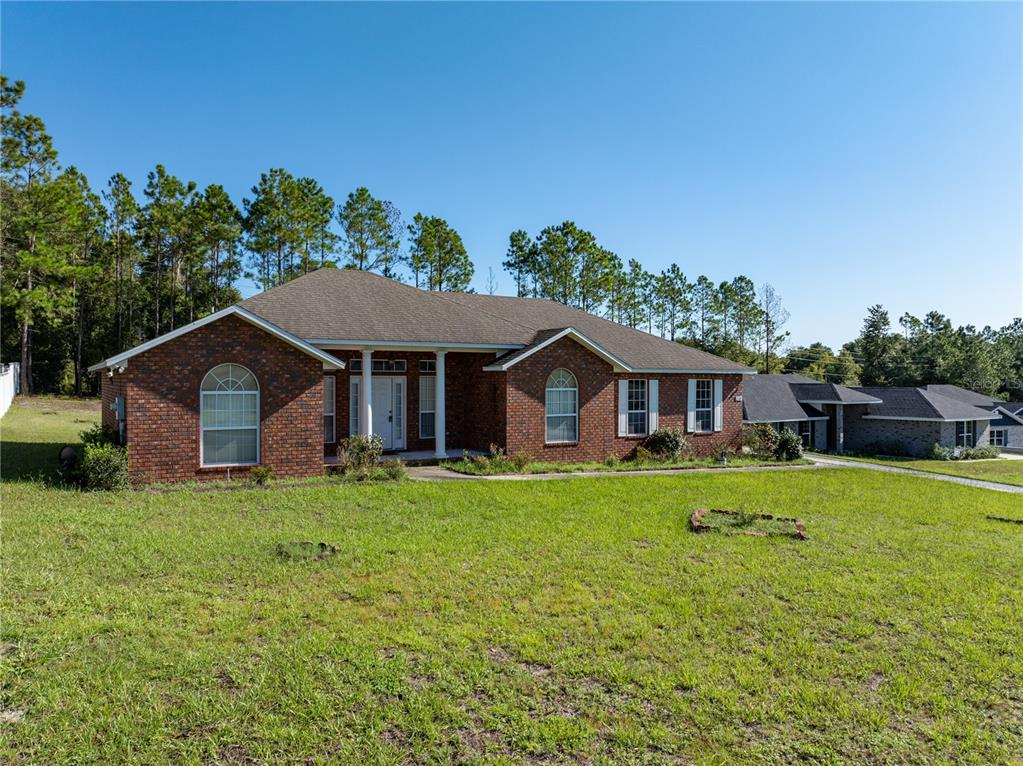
[{"x1": 506, "y1": 339, "x2": 743, "y2": 461}]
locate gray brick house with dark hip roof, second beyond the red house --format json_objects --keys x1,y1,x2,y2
[{"x1": 845, "y1": 386, "x2": 999, "y2": 455}]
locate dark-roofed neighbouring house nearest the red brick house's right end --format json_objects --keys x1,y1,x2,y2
[{"x1": 743, "y1": 375, "x2": 881, "y2": 452}]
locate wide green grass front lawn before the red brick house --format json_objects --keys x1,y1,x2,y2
[{"x1": 6, "y1": 396, "x2": 1023, "y2": 764}]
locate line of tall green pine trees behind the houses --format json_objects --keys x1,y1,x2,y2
[{"x1": 0, "y1": 77, "x2": 1023, "y2": 399}]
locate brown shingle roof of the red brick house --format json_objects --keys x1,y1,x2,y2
[{"x1": 240, "y1": 269, "x2": 749, "y2": 373}]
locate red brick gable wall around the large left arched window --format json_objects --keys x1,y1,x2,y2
[{"x1": 102, "y1": 316, "x2": 323, "y2": 484}]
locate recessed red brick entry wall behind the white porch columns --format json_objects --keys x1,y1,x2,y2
[{"x1": 324, "y1": 351, "x2": 504, "y2": 454}]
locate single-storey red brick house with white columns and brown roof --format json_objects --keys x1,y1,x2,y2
[{"x1": 90, "y1": 269, "x2": 754, "y2": 483}]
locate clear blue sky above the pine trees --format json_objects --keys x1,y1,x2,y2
[{"x1": 0, "y1": 2, "x2": 1023, "y2": 346}]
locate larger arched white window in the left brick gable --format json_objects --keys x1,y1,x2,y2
[{"x1": 199, "y1": 364, "x2": 259, "y2": 465}]
